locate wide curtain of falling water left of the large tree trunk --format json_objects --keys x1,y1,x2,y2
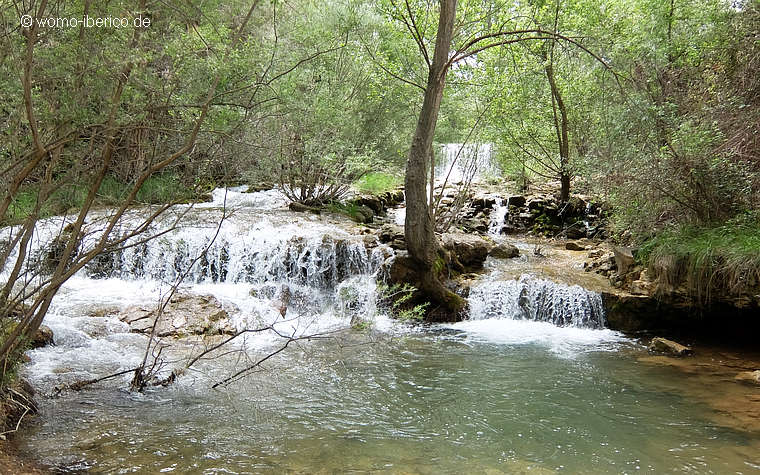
[{"x1": 88, "y1": 221, "x2": 384, "y2": 289}]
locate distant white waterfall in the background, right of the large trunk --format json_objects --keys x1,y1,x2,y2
[{"x1": 435, "y1": 143, "x2": 495, "y2": 185}]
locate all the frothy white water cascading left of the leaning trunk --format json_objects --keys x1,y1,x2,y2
[{"x1": 10, "y1": 189, "x2": 398, "y2": 391}]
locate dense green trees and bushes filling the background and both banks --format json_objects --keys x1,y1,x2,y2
[{"x1": 0, "y1": 0, "x2": 760, "y2": 378}]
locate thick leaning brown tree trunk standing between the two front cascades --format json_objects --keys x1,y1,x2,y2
[{"x1": 404, "y1": 0, "x2": 465, "y2": 320}]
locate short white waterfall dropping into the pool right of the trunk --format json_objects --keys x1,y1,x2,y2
[{"x1": 469, "y1": 275, "x2": 605, "y2": 328}]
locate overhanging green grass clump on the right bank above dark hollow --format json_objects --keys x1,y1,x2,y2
[{"x1": 637, "y1": 212, "x2": 760, "y2": 302}]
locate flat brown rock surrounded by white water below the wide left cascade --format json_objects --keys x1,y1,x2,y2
[{"x1": 119, "y1": 294, "x2": 235, "y2": 337}]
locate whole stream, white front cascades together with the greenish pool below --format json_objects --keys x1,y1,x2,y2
[{"x1": 7, "y1": 188, "x2": 760, "y2": 474}]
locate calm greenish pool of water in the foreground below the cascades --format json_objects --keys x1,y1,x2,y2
[{"x1": 22, "y1": 330, "x2": 760, "y2": 474}]
